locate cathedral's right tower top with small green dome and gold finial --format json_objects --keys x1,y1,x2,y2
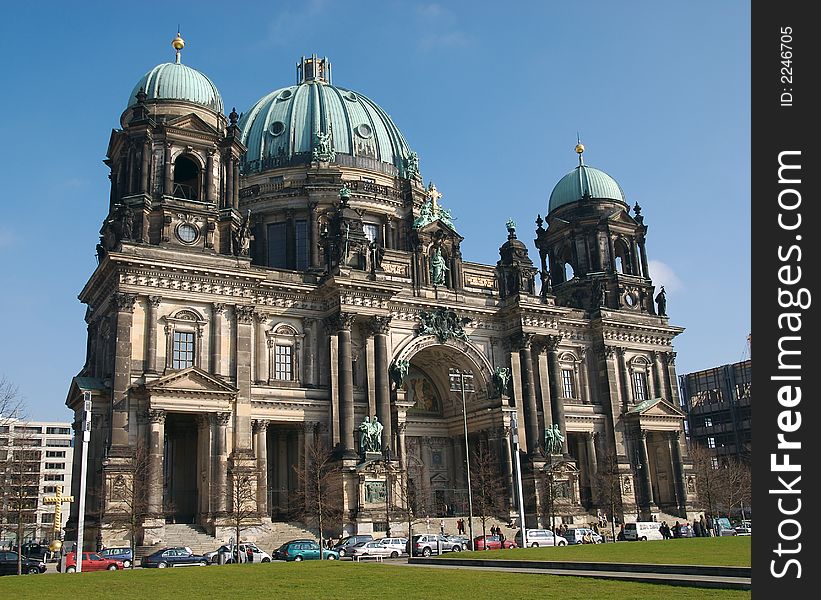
[{"x1": 536, "y1": 143, "x2": 663, "y2": 314}]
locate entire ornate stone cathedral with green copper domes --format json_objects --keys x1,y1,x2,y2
[{"x1": 66, "y1": 35, "x2": 695, "y2": 545}]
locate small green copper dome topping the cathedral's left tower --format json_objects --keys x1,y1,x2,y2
[{"x1": 128, "y1": 63, "x2": 223, "y2": 113}]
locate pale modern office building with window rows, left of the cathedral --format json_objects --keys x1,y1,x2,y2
[{"x1": 0, "y1": 418, "x2": 74, "y2": 542}]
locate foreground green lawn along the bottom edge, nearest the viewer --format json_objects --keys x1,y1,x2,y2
[{"x1": 0, "y1": 561, "x2": 750, "y2": 600}]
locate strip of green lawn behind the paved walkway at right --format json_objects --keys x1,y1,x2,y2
[{"x1": 442, "y1": 536, "x2": 752, "y2": 567}]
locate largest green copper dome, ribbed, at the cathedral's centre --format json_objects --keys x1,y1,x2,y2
[{"x1": 239, "y1": 57, "x2": 417, "y2": 177}]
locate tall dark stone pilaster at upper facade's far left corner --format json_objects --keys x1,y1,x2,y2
[{"x1": 110, "y1": 292, "x2": 137, "y2": 452}]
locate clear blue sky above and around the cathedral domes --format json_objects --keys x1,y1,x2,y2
[{"x1": 0, "y1": 0, "x2": 751, "y2": 419}]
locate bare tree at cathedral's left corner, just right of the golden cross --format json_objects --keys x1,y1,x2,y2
[{"x1": 99, "y1": 444, "x2": 152, "y2": 569}]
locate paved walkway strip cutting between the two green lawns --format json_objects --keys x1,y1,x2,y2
[{"x1": 401, "y1": 558, "x2": 752, "y2": 590}]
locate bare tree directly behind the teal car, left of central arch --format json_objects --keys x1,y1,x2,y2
[{"x1": 294, "y1": 435, "x2": 344, "y2": 559}]
